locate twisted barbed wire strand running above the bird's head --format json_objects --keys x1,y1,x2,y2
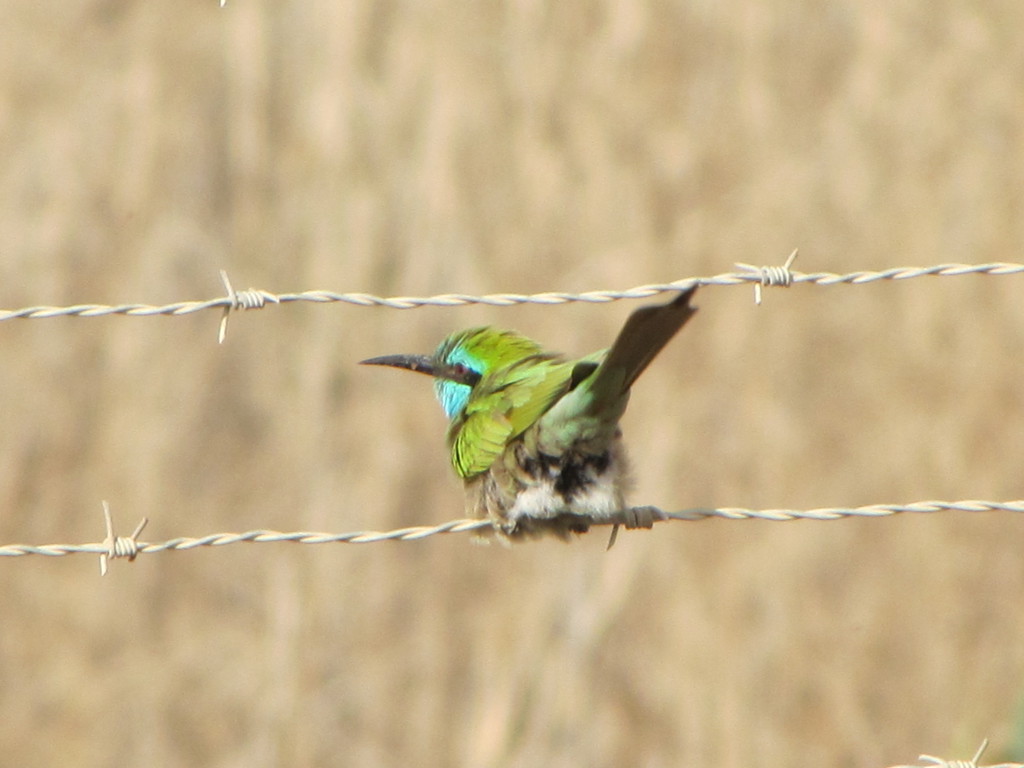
[{"x1": 0, "y1": 264, "x2": 1024, "y2": 321}]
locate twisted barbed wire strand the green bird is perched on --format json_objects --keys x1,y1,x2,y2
[{"x1": 0, "y1": 500, "x2": 1024, "y2": 573}]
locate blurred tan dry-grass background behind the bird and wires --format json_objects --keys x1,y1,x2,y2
[{"x1": 0, "y1": 0, "x2": 1024, "y2": 768}]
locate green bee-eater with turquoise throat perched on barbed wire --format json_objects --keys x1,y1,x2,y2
[{"x1": 362, "y1": 286, "x2": 696, "y2": 539}]
